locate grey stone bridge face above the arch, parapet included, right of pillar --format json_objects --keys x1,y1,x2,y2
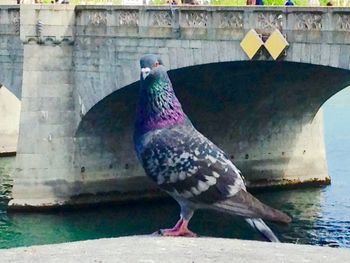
[{"x1": 75, "y1": 6, "x2": 350, "y2": 120}]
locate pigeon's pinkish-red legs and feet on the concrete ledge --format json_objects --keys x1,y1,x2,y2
[{"x1": 159, "y1": 207, "x2": 197, "y2": 237}]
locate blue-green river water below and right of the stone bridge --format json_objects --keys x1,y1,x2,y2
[{"x1": 0, "y1": 88, "x2": 350, "y2": 251}]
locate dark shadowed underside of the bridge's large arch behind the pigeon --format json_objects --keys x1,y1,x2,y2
[{"x1": 75, "y1": 61, "x2": 350, "y2": 198}]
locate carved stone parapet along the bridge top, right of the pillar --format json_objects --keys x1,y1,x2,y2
[{"x1": 76, "y1": 6, "x2": 350, "y2": 43}]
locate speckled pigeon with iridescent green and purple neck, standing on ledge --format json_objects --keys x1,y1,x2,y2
[{"x1": 133, "y1": 54, "x2": 291, "y2": 242}]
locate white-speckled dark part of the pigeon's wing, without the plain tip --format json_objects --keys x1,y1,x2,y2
[{"x1": 142, "y1": 126, "x2": 245, "y2": 204}]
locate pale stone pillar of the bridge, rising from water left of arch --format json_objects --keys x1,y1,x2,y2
[{"x1": 9, "y1": 5, "x2": 75, "y2": 206}]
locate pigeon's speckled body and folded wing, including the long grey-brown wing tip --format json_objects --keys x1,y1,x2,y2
[{"x1": 140, "y1": 121, "x2": 291, "y2": 223}]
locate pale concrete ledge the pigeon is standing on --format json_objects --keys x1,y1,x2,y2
[{"x1": 0, "y1": 236, "x2": 350, "y2": 263}]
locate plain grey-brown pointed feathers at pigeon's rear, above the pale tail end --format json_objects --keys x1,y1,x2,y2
[{"x1": 213, "y1": 190, "x2": 292, "y2": 224}]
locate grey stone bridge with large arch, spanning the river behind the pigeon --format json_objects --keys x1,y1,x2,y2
[{"x1": 0, "y1": 5, "x2": 350, "y2": 208}]
